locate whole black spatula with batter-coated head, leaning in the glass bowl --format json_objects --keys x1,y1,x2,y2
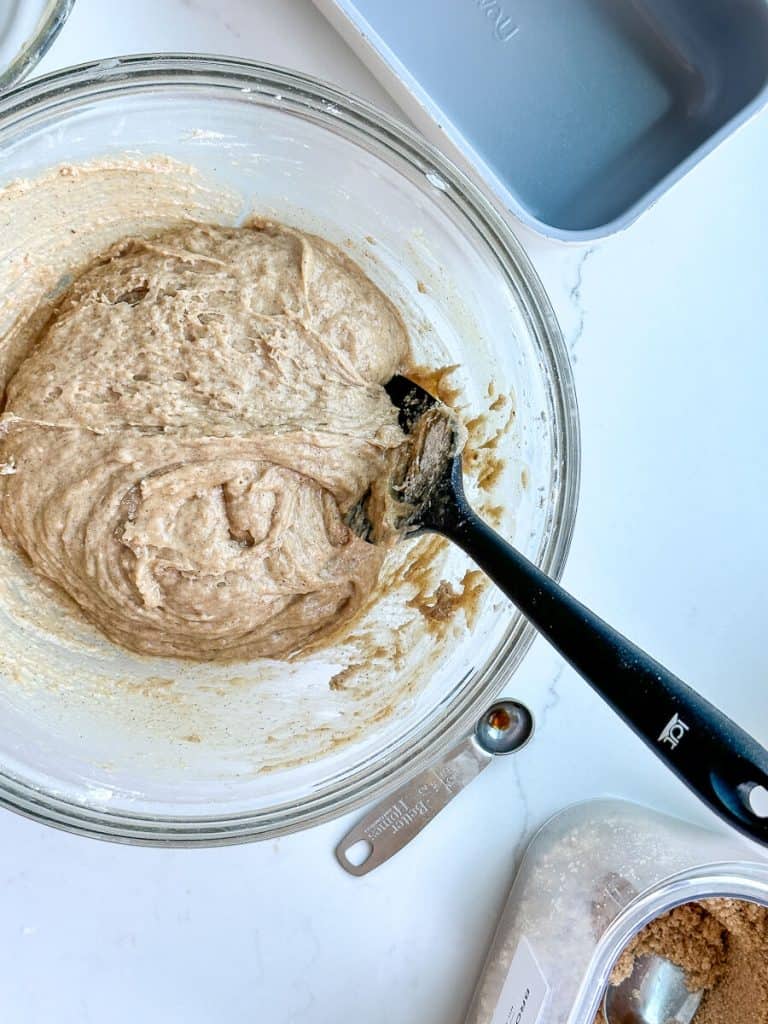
[{"x1": 376, "y1": 376, "x2": 768, "y2": 845}]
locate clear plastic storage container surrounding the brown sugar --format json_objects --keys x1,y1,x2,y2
[{"x1": 466, "y1": 800, "x2": 768, "y2": 1024}]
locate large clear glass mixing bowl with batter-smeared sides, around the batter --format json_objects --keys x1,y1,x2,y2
[{"x1": 0, "y1": 56, "x2": 578, "y2": 844}]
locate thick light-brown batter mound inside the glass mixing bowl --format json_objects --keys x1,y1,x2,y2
[{"x1": 0, "y1": 221, "x2": 410, "y2": 659}]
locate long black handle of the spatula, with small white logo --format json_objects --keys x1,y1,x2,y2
[{"x1": 439, "y1": 502, "x2": 768, "y2": 845}]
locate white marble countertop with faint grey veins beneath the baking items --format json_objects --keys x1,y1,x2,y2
[{"x1": 0, "y1": 0, "x2": 768, "y2": 1024}]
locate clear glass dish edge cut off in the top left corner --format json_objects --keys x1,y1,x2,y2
[{"x1": 0, "y1": 0, "x2": 75, "y2": 92}]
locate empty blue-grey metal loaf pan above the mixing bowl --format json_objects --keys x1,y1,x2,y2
[{"x1": 315, "y1": 0, "x2": 768, "y2": 241}]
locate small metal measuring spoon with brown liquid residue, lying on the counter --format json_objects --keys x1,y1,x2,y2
[{"x1": 336, "y1": 700, "x2": 534, "y2": 876}]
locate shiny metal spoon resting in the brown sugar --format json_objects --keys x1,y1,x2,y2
[{"x1": 603, "y1": 956, "x2": 703, "y2": 1024}]
